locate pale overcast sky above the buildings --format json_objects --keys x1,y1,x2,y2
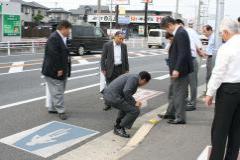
[{"x1": 25, "y1": 0, "x2": 240, "y2": 19}]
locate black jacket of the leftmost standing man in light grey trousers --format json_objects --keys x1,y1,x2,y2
[{"x1": 42, "y1": 32, "x2": 71, "y2": 80}]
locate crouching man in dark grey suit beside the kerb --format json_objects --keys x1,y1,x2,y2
[{"x1": 103, "y1": 71, "x2": 151, "y2": 138}]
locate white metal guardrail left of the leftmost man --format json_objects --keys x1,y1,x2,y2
[{"x1": 0, "y1": 41, "x2": 46, "y2": 56}]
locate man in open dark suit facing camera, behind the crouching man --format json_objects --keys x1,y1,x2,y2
[{"x1": 101, "y1": 31, "x2": 129, "y2": 111}]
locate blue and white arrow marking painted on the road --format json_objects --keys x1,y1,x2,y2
[{"x1": 0, "y1": 121, "x2": 99, "y2": 158}]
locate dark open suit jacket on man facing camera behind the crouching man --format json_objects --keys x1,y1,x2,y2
[{"x1": 101, "y1": 41, "x2": 129, "y2": 78}]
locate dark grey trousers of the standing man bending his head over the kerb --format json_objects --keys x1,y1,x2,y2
[{"x1": 166, "y1": 76, "x2": 188, "y2": 121}]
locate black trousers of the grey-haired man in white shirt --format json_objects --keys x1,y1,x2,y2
[{"x1": 210, "y1": 83, "x2": 240, "y2": 160}]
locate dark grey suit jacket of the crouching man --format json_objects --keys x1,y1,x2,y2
[{"x1": 103, "y1": 73, "x2": 139, "y2": 106}]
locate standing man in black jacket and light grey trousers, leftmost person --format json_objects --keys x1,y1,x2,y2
[{"x1": 42, "y1": 21, "x2": 72, "y2": 120}]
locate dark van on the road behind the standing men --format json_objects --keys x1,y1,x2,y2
[{"x1": 68, "y1": 24, "x2": 110, "y2": 56}]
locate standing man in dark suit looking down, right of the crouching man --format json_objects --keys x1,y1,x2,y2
[{"x1": 160, "y1": 16, "x2": 193, "y2": 124}]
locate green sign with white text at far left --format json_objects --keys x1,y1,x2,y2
[{"x1": 3, "y1": 15, "x2": 21, "y2": 36}]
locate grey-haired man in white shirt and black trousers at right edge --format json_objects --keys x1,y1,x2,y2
[{"x1": 205, "y1": 19, "x2": 240, "y2": 160}]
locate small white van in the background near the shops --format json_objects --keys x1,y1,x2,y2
[{"x1": 147, "y1": 29, "x2": 167, "y2": 48}]
